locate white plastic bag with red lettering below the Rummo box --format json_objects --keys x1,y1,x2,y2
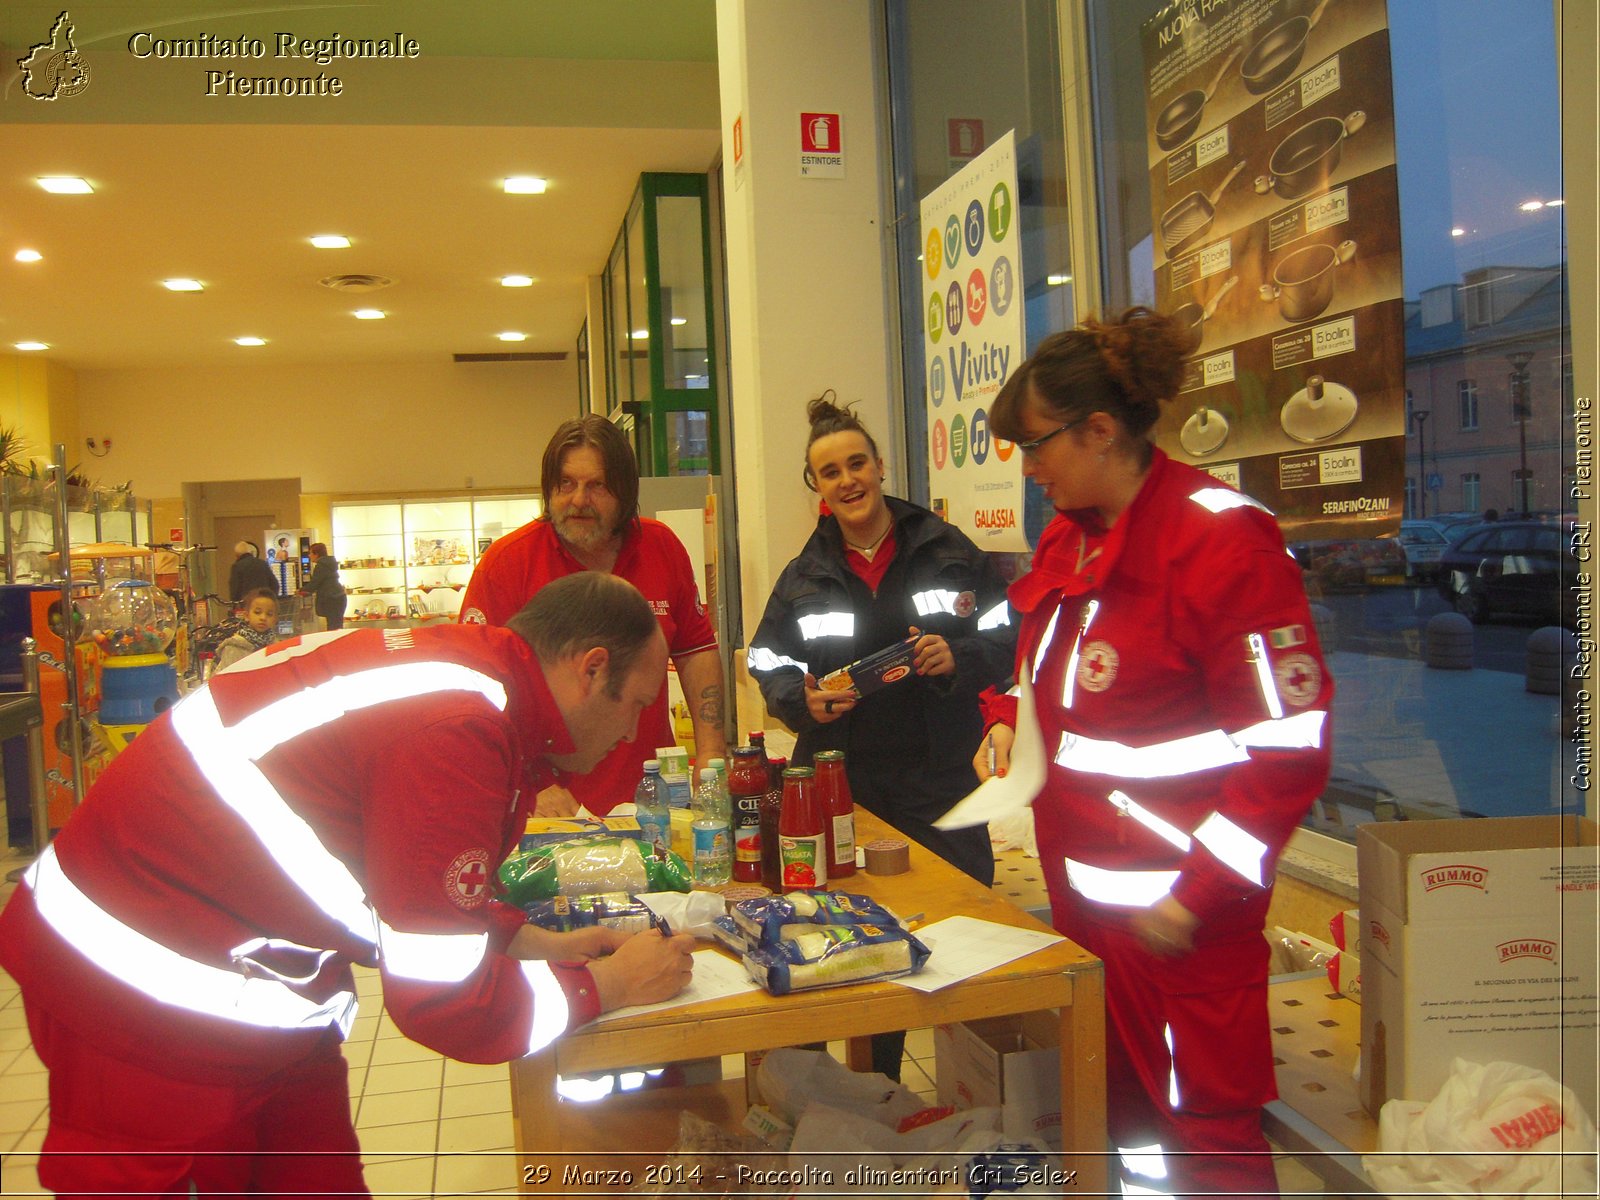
[{"x1": 1362, "y1": 1058, "x2": 1595, "y2": 1197}]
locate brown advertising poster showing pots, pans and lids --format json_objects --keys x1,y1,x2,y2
[{"x1": 1142, "y1": 0, "x2": 1406, "y2": 538}]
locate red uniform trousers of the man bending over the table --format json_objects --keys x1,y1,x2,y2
[{"x1": 24, "y1": 998, "x2": 371, "y2": 1197}]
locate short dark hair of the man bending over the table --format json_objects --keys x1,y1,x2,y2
[{"x1": 506, "y1": 571, "x2": 661, "y2": 699}]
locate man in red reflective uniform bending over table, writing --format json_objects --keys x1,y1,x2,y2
[{"x1": 0, "y1": 573, "x2": 693, "y2": 1197}]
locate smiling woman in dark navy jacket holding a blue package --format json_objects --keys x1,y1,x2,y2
[{"x1": 747, "y1": 392, "x2": 1016, "y2": 1078}]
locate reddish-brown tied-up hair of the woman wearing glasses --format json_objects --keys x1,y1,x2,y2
[{"x1": 989, "y1": 306, "x2": 1187, "y2": 453}]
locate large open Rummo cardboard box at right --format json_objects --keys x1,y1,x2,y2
[{"x1": 1355, "y1": 816, "x2": 1600, "y2": 1115}]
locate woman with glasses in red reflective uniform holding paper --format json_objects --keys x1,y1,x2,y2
[{"x1": 974, "y1": 309, "x2": 1333, "y2": 1195}]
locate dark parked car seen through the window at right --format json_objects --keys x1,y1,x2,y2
[{"x1": 1438, "y1": 520, "x2": 1578, "y2": 629}]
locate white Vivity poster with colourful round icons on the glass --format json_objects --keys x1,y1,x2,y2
[{"x1": 920, "y1": 131, "x2": 1030, "y2": 552}]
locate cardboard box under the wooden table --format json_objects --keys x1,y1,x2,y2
[{"x1": 933, "y1": 1013, "x2": 1061, "y2": 1150}]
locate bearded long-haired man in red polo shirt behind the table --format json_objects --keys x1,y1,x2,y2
[{"x1": 461, "y1": 416, "x2": 728, "y2": 816}]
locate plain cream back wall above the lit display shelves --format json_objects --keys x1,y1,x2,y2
[{"x1": 67, "y1": 357, "x2": 578, "y2": 498}]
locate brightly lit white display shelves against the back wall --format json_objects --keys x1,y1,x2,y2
[{"x1": 328, "y1": 494, "x2": 544, "y2": 624}]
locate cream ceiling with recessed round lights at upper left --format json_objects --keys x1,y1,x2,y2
[{"x1": 0, "y1": 0, "x2": 718, "y2": 371}]
